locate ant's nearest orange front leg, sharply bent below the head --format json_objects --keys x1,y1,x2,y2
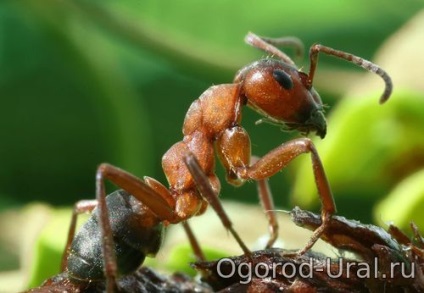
[{"x1": 247, "y1": 138, "x2": 336, "y2": 255}]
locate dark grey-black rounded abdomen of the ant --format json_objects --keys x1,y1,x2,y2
[{"x1": 66, "y1": 190, "x2": 164, "y2": 281}]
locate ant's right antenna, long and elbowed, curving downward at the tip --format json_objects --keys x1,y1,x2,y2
[{"x1": 308, "y1": 44, "x2": 393, "y2": 104}]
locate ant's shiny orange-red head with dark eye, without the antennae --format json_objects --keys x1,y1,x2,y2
[{"x1": 235, "y1": 59, "x2": 327, "y2": 138}]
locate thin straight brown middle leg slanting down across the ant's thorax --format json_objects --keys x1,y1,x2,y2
[{"x1": 184, "y1": 153, "x2": 251, "y2": 255}]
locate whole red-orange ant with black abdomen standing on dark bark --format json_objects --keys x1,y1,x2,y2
[{"x1": 58, "y1": 33, "x2": 392, "y2": 292}]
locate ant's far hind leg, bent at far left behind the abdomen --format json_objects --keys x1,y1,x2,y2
[{"x1": 60, "y1": 200, "x2": 97, "y2": 272}]
